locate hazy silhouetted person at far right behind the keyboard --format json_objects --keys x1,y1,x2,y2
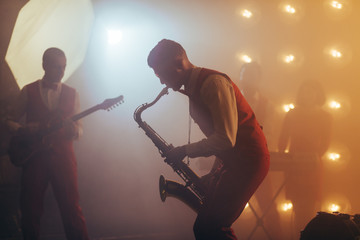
[{"x1": 278, "y1": 80, "x2": 332, "y2": 237}]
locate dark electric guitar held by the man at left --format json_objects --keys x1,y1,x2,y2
[{"x1": 8, "y1": 95, "x2": 124, "y2": 167}]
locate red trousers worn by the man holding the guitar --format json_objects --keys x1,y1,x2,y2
[{"x1": 20, "y1": 149, "x2": 89, "y2": 240}]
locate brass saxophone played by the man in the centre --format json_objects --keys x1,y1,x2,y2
[{"x1": 134, "y1": 87, "x2": 206, "y2": 212}]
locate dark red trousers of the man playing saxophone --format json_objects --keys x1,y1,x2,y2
[{"x1": 193, "y1": 158, "x2": 269, "y2": 240}]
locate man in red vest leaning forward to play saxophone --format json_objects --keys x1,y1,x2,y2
[{"x1": 147, "y1": 39, "x2": 270, "y2": 240}]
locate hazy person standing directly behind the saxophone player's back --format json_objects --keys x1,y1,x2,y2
[{"x1": 239, "y1": 62, "x2": 283, "y2": 240}]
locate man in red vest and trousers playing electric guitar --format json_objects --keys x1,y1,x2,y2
[{"x1": 8, "y1": 48, "x2": 89, "y2": 240}]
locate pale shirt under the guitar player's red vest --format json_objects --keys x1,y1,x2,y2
[{"x1": 15, "y1": 80, "x2": 82, "y2": 138}]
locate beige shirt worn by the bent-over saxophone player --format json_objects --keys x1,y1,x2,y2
[{"x1": 185, "y1": 67, "x2": 238, "y2": 158}]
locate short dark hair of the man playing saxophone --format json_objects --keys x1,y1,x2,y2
[{"x1": 147, "y1": 39, "x2": 187, "y2": 68}]
